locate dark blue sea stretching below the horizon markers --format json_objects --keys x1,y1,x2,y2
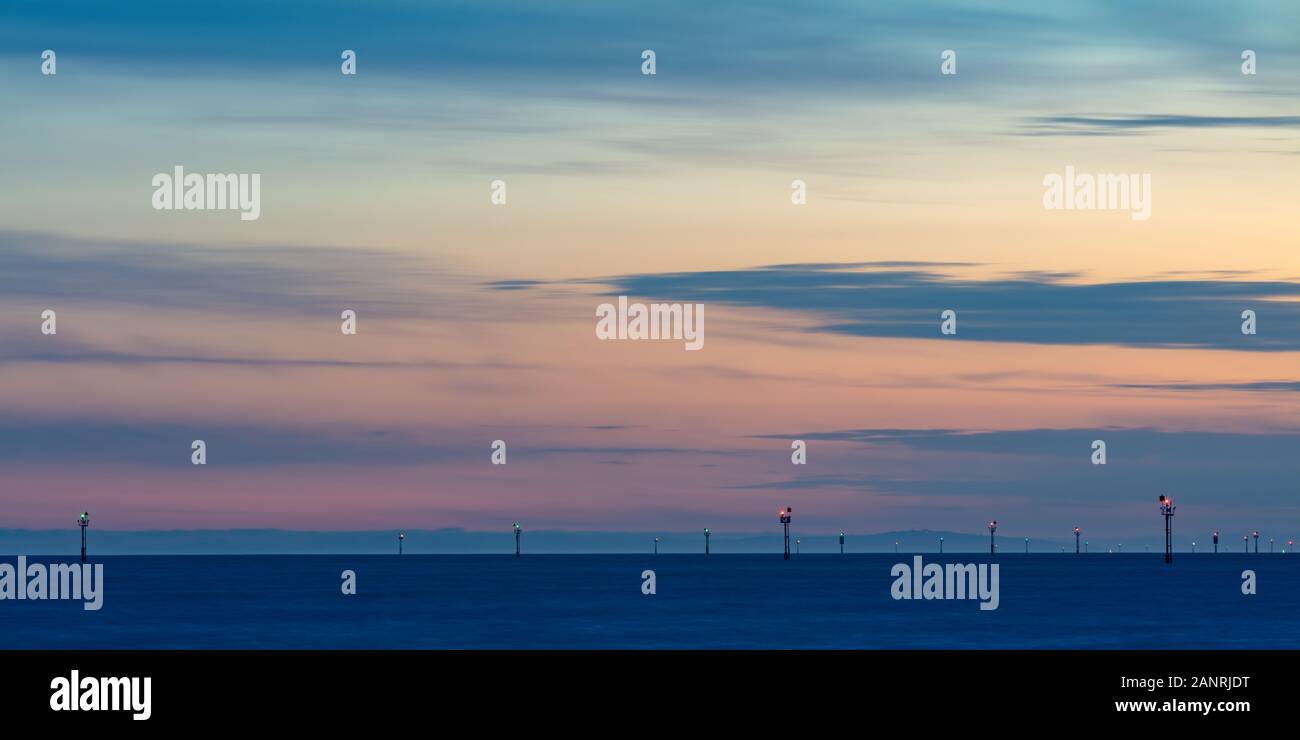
[{"x1": 0, "y1": 554, "x2": 1300, "y2": 649}]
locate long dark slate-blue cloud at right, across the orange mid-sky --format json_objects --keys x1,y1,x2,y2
[{"x1": 535, "y1": 263, "x2": 1300, "y2": 351}]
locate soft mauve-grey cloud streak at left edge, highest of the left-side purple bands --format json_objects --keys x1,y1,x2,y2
[{"x1": 0, "y1": 231, "x2": 456, "y2": 316}]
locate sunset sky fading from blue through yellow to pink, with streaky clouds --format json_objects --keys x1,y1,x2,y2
[{"x1": 0, "y1": 0, "x2": 1300, "y2": 541}]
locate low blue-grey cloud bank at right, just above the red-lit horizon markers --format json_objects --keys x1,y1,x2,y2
[{"x1": 735, "y1": 427, "x2": 1300, "y2": 507}]
